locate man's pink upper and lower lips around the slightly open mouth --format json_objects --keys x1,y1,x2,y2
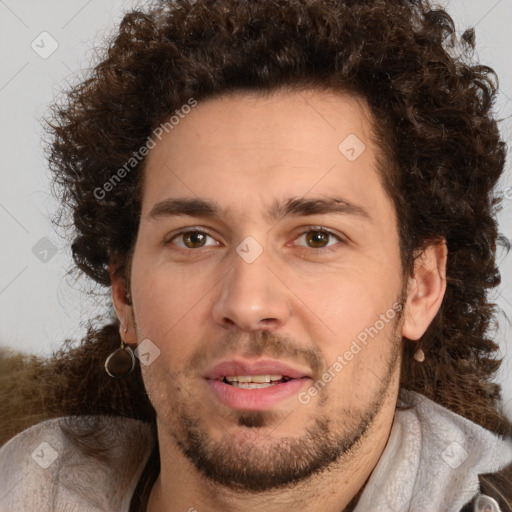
[{"x1": 205, "y1": 359, "x2": 311, "y2": 411}]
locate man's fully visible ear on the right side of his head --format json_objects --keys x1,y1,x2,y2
[{"x1": 402, "y1": 240, "x2": 448, "y2": 340}]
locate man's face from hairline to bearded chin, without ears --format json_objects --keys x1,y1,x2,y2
[{"x1": 123, "y1": 91, "x2": 404, "y2": 491}]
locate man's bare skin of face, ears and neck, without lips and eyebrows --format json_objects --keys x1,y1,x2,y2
[{"x1": 111, "y1": 90, "x2": 447, "y2": 512}]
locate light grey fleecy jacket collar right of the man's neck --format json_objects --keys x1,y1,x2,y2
[{"x1": 355, "y1": 390, "x2": 512, "y2": 512}]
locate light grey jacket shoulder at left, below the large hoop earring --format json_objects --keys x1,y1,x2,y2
[{"x1": 0, "y1": 416, "x2": 155, "y2": 512}]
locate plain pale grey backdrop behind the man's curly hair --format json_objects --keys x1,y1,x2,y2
[{"x1": 0, "y1": 0, "x2": 512, "y2": 418}]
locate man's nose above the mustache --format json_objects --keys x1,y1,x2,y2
[{"x1": 213, "y1": 251, "x2": 291, "y2": 331}]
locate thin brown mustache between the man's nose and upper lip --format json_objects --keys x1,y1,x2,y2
[{"x1": 184, "y1": 331, "x2": 327, "y2": 374}]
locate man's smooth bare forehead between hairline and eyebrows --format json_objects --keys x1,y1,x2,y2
[{"x1": 143, "y1": 90, "x2": 392, "y2": 225}]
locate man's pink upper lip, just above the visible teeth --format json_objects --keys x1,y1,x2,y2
[{"x1": 204, "y1": 359, "x2": 311, "y2": 380}]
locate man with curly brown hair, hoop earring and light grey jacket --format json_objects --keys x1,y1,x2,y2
[{"x1": 0, "y1": 0, "x2": 512, "y2": 512}]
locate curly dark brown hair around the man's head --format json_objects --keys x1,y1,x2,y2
[{"x1": 41, "y1": 0, "x2": 511, "y2": 508}]
